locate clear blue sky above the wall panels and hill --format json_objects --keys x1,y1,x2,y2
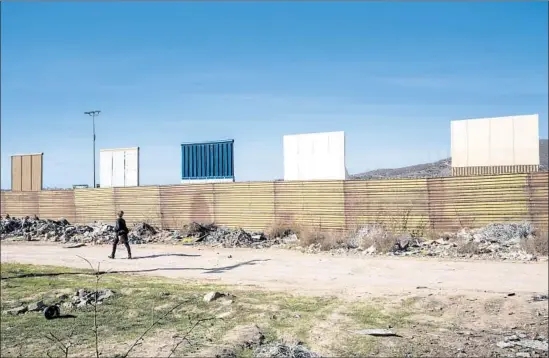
[{"x1": 1, "y1": 2, "x2": 548, "y2": 188}]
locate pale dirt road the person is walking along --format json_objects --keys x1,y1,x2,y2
[{"x1": 1, "y1": 243, "x2": 549, "y2": 297}]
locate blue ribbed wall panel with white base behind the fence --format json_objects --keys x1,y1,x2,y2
[{"x1": 181, "y1": 140, "x2": 234, "y2": 179}]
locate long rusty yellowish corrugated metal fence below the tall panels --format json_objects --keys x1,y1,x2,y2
[{"x1": 0, "y1": 173, "x2": 549, "y2": 231}]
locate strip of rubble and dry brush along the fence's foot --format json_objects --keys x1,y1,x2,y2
[{"x1": 0, "y1": 217, "x2": 538, "y2": 261}]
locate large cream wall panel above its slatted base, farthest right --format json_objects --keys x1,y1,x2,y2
[{"x1": 451, "y1": 114, "x2": 539, "y2": 167}]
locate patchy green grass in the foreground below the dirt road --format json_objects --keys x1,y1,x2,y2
[{"x1": 1, "y1": 264, "x2": 428, "y2": 357}]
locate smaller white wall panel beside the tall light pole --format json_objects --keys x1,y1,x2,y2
[{"x1": 99, "y1": 147, "x2": 139, "y2": 188}]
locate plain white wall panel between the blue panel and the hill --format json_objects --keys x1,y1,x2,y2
[{"x1": 283, "y1": 132, "x2": 347, "y2": 180}]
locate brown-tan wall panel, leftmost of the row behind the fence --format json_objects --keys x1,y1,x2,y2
[{"x1": 11, "y1": 153, "x2": 44, "y2": 192}]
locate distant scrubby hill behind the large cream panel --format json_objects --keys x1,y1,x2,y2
[{"x1": 351, "y1": 139, "x2": 549, "y2": 179}]
